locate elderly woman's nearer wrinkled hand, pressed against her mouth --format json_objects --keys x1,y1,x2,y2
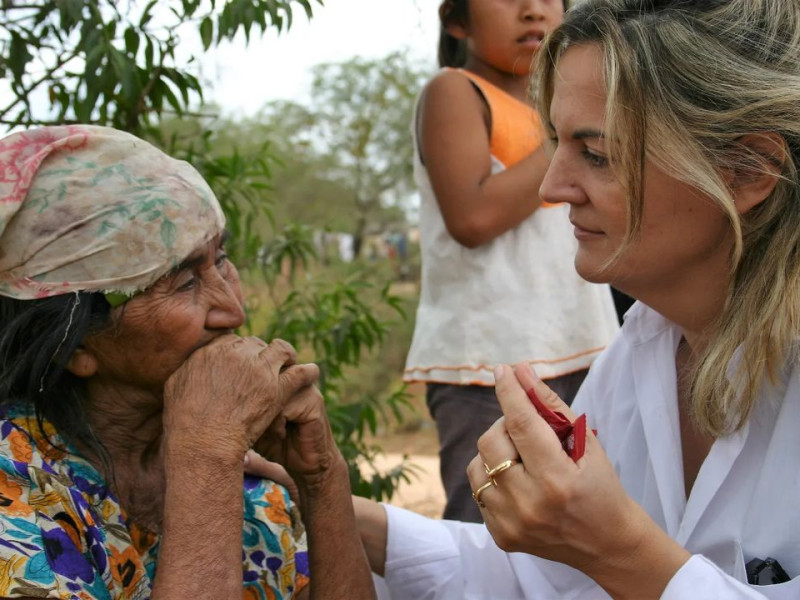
[{"x1": 164, "y1": 335, "x2": 319, "y2": 460}]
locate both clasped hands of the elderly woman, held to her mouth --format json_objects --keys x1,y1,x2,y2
[{"x1": 164, "y1": 335, "x2": 339, "y2": 488}]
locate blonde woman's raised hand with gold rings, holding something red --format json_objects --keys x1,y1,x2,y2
[{"x1": 467, "y1": 365, "x2": 689, "y2": 597}]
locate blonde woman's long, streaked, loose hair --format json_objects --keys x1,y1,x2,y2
[{"x1": 534, "y1": 0, "x2": 800, "y2": 437}]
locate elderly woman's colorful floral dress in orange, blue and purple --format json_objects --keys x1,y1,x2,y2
[{"x1": 0, "y1": 406, "x2": 308, "y2": 600}]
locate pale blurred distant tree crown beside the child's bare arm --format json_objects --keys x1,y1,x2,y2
[{"x1": 261, "y1": 52, "x2": 429, "y2": 256}]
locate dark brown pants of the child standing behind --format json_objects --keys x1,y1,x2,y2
[{"x1": 425, "y1": 370, "x2": 587, "y2": 523}]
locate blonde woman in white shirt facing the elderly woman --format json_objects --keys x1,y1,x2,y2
[{"x1": 357, "y1": 0, "x2": 800, "y2": 600}]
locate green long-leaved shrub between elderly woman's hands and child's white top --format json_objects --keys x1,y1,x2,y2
[{"x1": 257, "y1": 258, "x2": 413, "y2": 498}]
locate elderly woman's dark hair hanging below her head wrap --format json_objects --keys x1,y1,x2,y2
[{"x1": 0, "y1": 292, "x2": 111, "y2": 474}]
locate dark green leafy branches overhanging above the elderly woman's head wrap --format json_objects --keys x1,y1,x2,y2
[{"x1": 0, "y1": 0, "x2": 321, "y2": 132}]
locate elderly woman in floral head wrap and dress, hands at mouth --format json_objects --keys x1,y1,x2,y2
[{"x1": 0, "y1": 126, "x2": 372, "y2": 599}]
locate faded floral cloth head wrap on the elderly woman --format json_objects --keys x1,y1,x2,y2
[{"x1": 0, "y1": 125, "x2": 225, "y2": 300}]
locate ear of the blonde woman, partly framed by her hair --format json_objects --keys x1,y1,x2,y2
[{"x1": 731, "y1": 132, "x2": 787, "y2": 215}]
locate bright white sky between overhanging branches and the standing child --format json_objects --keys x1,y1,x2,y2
[{"x1": 185, "y1": 0, "x2": 440, "y2": 116}]
